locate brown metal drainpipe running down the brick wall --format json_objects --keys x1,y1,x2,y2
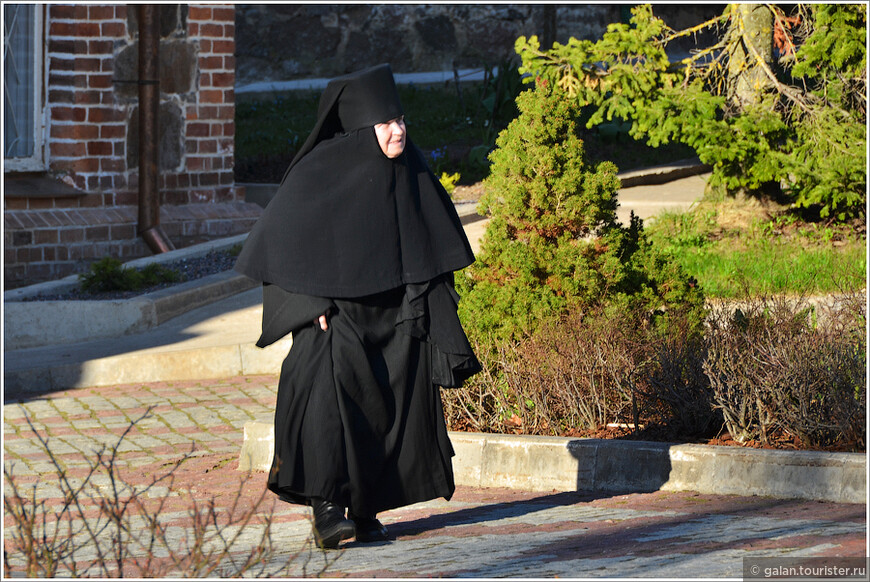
[{"x1": 137, "y1": 4, "x2": 175, "y2": 254}]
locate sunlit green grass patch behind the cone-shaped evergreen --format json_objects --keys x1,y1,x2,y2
[{"x1": 647, "y1": 199, "x2": 867, "y2": 299}]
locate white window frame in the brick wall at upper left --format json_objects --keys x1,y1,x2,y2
[{"x1": 3, "y1": 4, "x2": 48, "y2": 173}]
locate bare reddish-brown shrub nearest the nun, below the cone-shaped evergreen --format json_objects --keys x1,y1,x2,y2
[{"x1": 444, "y1": 309, "x2": 640, "y2": 435}]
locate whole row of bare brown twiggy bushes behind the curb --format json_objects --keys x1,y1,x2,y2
[{"x1": 444, "y1": 294, "x2": 866, "y2": 450}]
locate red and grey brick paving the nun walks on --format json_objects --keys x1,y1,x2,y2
[{"x1": 3, "y1": 376, "x2": 867, "y2": 578}]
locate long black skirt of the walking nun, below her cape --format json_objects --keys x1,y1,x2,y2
[{"x1": 268, "y1": 288, "x2": 454, "y2": 515}]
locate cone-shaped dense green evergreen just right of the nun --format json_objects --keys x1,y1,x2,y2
[{"x1": 457, "y1": 80, "x2": 703, "y2": 343}]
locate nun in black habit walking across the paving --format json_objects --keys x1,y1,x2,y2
[{"x1": 235, "y1": 65, "x2": 480, "y2": 548}]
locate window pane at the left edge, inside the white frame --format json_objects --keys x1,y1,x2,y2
[{"x1": 3, "y1": 4, "x2": 37, "y2": 158}]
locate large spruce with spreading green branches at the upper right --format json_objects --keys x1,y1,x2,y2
[{"x1": 517, "y1": 4, "x2": 867, "y2": 220}]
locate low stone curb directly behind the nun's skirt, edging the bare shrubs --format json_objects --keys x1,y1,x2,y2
[{"x1": 239, "y1": 422, "x2": 867, "y2": 503}]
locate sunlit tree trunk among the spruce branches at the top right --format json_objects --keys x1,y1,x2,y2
[{"x1": 728, "y1": 4, "x2": 773, "y2": 113}]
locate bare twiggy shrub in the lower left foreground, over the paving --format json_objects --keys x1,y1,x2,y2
[{"x1": 3, "y1": 413, "x2": 338, "y2": 578}]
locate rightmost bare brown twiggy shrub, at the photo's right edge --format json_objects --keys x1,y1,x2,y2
[{"x1": 704, "y1": 297, "x2": 866, "y2": 448}]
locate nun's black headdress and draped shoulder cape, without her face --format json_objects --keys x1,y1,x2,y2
[{"x1": 235, "y1": 65, "x2": 474, "y2": 298}]
